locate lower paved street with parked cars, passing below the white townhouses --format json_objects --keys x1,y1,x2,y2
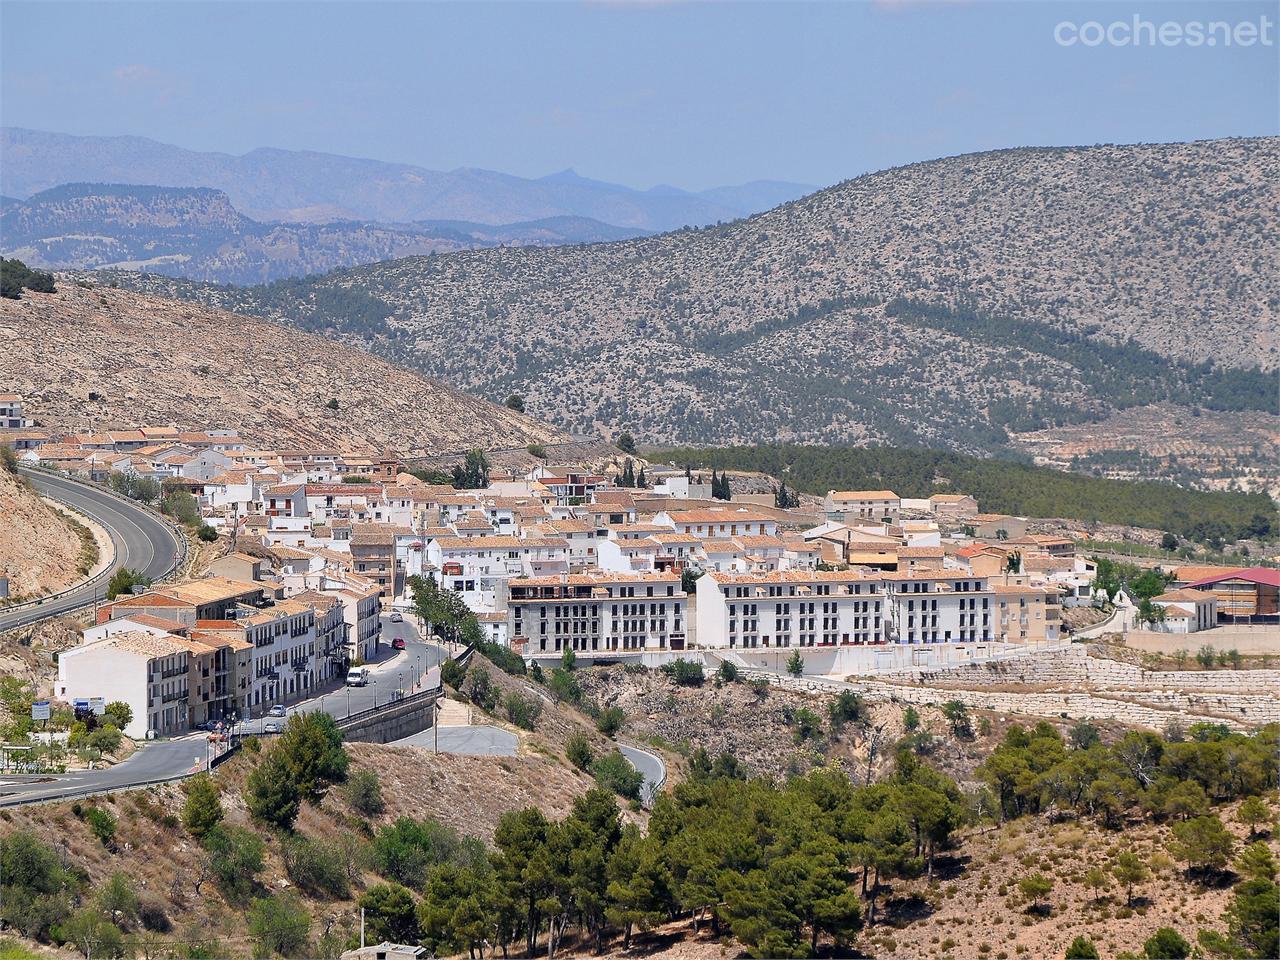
[{"x1": 0, "y1": 617, "x2": 447, "y2": 806}]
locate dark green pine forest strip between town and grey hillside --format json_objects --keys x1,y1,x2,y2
[{"x1": 645, "y1": 444, "x2": 1280, "y2": 544}]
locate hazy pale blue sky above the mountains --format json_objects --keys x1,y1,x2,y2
[{"x1": 0, "y1": 0, "x2": 1280, "y2": 188}]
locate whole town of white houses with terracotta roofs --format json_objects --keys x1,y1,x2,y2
[{"x1": 12, "y1": 394, "x2": 1277, "y2": 737}]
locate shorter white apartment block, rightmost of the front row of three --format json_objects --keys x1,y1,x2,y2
[{"x1": 882, "y1": 570, "x2": 995, "y2": 644}]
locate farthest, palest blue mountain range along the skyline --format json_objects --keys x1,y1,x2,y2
[{"x1": 0, "y1": 127, "x2": 815, "y2": 229}]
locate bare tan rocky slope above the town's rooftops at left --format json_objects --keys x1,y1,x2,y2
[{"x1": 0, "y1": 275, "x2": 563, "y2": 453}]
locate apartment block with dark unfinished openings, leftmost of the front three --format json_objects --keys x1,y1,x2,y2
[{"x1": 507, "y1": 571, "x2": 687, "y2": 655}]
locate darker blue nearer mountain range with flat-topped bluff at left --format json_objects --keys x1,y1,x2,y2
[{"x1": 0, "y1": 183, "x2": 644, "y2": 284}]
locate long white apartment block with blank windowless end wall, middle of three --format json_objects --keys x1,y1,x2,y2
[{"x1": 696, "y1": 570, "x2": 884, "y2": 649}]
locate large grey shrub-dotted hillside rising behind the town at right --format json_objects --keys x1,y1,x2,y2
[{"x1": 112, "y1": 138, "x2": 1280, "y2": 451}]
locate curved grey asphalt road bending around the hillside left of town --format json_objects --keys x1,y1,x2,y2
[{"x1": 0, "y1": 470, "x2": 179, "y2": 632}]
